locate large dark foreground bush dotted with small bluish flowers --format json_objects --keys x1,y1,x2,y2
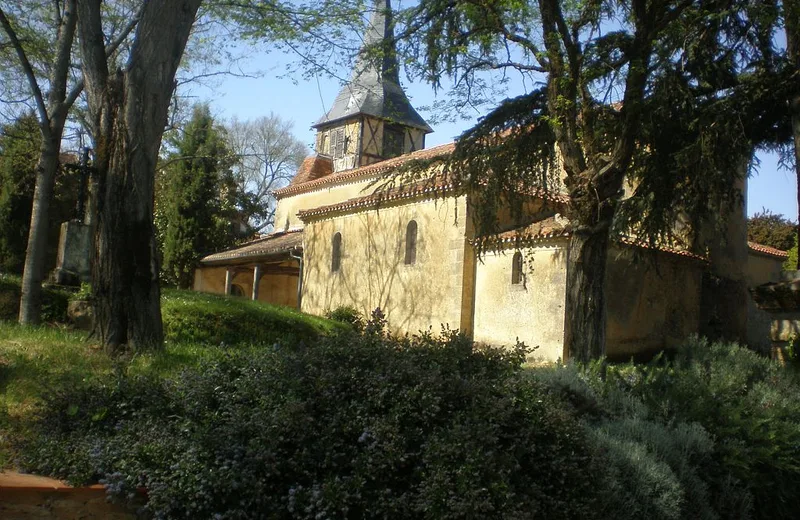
[{"x1": 20, "y1": 316, "x2": 598, "y2": 518}]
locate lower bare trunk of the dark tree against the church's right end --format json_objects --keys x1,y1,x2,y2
[{"x1": 564, "y1": 226, "x2": 609, "y2": 362}]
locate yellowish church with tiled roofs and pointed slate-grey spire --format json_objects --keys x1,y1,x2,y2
[{"x1": 194, "y1": 0, "x2": 785, "y2": 361}]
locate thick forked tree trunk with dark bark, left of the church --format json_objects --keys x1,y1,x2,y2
[{"x1": 78, "y1": 0, "x2": 201, "y2": 354}]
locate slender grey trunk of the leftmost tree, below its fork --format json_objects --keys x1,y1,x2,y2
[{"x1": 19, "y1": 139, "x2": 61, "y2": 325}]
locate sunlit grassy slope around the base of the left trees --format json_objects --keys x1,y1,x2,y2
[{"x1": 0, "y1": 284, "x2": 346, "y2": 468}]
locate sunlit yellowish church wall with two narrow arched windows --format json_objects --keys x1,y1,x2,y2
[{"x1": 302, "y1": 196, "x2": 467, "y2": 333}]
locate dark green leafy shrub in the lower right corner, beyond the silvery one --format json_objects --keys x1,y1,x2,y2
[{"x1": 611, "y1": 340, "x2": 800, "y2": 519}]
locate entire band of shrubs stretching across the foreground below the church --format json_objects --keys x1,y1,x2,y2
[{"x1": 12, "y1": 315, "x2": 800, "y2": 520}]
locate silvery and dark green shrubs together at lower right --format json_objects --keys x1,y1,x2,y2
[{"x1": 534, "y1": 339, "x2": 800, "y2": 519}]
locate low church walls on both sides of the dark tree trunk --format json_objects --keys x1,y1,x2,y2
[{"x1": 474, "y1": 239, "x2": 704, "y2": 361}]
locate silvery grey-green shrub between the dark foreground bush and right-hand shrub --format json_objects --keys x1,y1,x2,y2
[{"x1": 532, "y1": 363, "x2": 717, "y2": 520}]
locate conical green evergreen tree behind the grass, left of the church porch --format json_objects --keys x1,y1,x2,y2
[{"x1": 155, "y1": 105, "x2": 237, "y2": 288}]
